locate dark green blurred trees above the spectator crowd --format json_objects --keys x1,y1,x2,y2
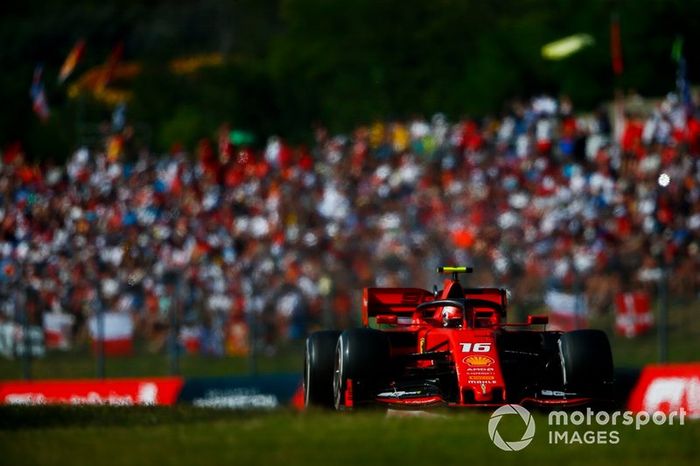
[{"x1": 0, "y1": 0, "x2": 700, "y2": 160}]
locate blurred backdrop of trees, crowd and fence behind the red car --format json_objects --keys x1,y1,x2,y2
[{"x1": 0, "y1": 0, "x2": 700, "y2": 379}]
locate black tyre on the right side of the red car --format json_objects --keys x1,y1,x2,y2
[{"x1": 559, "y1": 330, "x2": 613, "y2": 396}]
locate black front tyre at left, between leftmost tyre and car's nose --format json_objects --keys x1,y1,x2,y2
[{"x1": 333, "y1": 328, "x2": 390, "y2": 410}]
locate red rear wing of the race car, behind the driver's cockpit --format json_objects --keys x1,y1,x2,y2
[{"x1": 362, "y1": 288, "x2": 508, "y2": 327}]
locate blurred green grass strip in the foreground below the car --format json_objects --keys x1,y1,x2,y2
[{"x1": 0, "y1": 407, "x2": 700, "y2": 466}]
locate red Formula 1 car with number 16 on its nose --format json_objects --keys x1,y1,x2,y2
[{"x1": 304, "y1": 267, "x2": 613, "y2": 410}]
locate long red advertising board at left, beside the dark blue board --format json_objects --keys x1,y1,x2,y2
[{"x1": 0, "y1": 377, "x2": 184, "y2": 406}]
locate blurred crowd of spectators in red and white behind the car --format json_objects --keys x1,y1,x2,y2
[{"x1": 0, "y1": 89, "x2": 700, "y2": 355}]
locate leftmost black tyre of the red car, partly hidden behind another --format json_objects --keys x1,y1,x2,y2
[{"x1": 304, "y1": 330, "x2": 340, "y2": 408}]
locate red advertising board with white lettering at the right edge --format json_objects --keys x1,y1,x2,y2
[{"x1": 628, "y1": 363, "x2": 700, "y2": 419}]
